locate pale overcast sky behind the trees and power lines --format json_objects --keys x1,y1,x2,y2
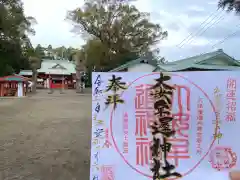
[{"x1": 23, "y1": 0, "x2": 240, "y2": 61}]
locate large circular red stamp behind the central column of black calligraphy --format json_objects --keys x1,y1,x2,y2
[{"x1": 109, "y1": 72, "x2": 217, "y2": 179}]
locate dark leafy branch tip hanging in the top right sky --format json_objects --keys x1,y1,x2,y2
[{"x1": 218, "y1": 0, "x2": 240, "y2": 14}]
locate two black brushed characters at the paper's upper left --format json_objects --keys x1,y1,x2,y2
[{"x1": 105, "y1": 75, "x2": 127, "y2": 109}]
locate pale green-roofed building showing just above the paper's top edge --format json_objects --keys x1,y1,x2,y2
[{"x1": 110, "y1": 49, "x2": 240, "y2": 72}]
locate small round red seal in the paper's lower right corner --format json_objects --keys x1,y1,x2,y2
[{"x1": 210, "y1": 146, "x2": 237, "y2": 171}]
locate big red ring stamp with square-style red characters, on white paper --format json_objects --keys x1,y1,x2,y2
[{"x1": 110, "y1": 73, "x2": 217, "y2": 179}]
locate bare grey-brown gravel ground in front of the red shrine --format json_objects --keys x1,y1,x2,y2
[{"x1": 0, "y1": 90, "x2": 91, "y2": 180}]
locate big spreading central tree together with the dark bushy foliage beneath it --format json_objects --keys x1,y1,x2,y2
[{"x1": 67, "y1": 1, "x2": 167, "y2": 70}]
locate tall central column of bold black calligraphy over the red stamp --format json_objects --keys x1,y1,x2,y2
[{"x1": 150, "y1": 73, "x2": 182, "y2": 180}]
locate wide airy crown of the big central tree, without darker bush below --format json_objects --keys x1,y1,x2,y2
[{"x1": 67, "y1": 0, "x2": 167, "y2": 63}]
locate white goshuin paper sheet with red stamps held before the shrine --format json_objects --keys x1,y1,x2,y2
[{"x1": 90, "y1": 71, "x2": 240, "y2": 180}]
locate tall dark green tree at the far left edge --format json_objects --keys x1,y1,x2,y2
[{"x1": 0, "y1": 0, "x2": 36, "y2": 75}]
